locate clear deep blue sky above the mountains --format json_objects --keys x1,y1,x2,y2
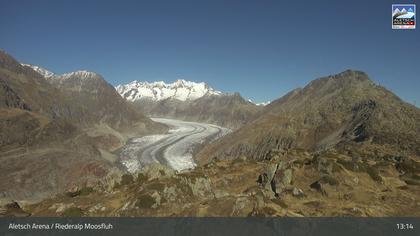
[{"x1": 0, "y1": 0, "x2": 420, "y2": 106}]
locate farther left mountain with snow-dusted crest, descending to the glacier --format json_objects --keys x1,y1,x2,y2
[{"x1": 23, "y1": 64, "x2": 166, "y2": 136}]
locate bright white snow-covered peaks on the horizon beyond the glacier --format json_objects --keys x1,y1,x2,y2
[{"x1": 116, "y1": 80, "x2": 223, "y2": 101}]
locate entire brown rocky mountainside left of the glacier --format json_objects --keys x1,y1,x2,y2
[{"x1": 0, "y1": 51, "x2": 165, "y2": 200}]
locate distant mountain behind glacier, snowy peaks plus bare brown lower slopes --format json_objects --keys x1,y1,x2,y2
[{"x1": 116, "y1": 80, "x2": 261, "y2": 129}]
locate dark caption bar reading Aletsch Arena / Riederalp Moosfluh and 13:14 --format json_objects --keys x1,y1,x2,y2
[{"x1": 0, "y1": 217, "x2": 420, "y2": 236}]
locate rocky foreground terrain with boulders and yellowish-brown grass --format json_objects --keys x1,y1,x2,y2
[{"x1": 1, "y1": 150, "x2": 420, "y2": 217}]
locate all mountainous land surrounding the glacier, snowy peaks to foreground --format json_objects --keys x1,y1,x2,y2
[{"x1": 0, "y1": 51, "x2": 420, "y2": 217}]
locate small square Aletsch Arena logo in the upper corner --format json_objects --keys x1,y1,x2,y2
[{"x1": 392, "y1": 4, "x2": 416, "y2": 29}]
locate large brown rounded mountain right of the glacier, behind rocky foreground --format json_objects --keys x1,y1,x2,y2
[{"x1": 198, "y1": 70, "x2": 420, "y2": 162}]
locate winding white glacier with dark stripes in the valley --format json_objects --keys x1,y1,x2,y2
[{"x1": 119, "y1": 118, "x2": 230, "y2": 173}]
